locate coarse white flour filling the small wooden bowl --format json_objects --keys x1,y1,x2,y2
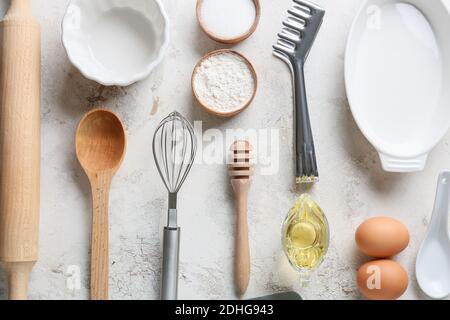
[{"x1": 194, "y1": 53, "x2": 255, "y2": 112}]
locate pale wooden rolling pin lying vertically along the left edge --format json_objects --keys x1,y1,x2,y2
[{"x1": 0, "y1": 0, "x2": 41, "y2": 300}]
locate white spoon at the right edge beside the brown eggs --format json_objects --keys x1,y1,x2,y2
[{"x1": 416, "y1": 171, "x2": 450, "y2": 299}]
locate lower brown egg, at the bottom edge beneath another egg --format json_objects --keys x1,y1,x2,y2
[{"x1": 357, "y1": 260, "x2": 408, "y2": 300}]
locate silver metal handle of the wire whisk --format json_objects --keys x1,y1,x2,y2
[{"x1": 161, "y1": 227, "x2": 180, "y2": 300}]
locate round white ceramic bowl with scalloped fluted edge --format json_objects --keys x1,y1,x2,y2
[{"x1": 62, "y1": 0, "x2": 169, "y2": 86}]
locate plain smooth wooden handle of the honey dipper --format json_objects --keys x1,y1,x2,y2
[{"x1": 234, "y1": 192, "x2": 250, "y2": 296}]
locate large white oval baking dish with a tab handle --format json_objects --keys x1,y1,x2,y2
[{"x1": 345, "y1": 0, "x2": 450, "y2": 172}]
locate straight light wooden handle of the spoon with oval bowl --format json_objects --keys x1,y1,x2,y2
[{"x1": 90, "y1": 174, "x2": 111, "y2": 300}]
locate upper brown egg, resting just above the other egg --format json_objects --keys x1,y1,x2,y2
[{"x1": 355, "y1": 217, "x2": 409, "y2": 258}]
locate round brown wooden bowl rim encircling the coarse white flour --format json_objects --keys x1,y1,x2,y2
[{"x1": 191, "y1": 49, "x2": 258, "y2": 118}]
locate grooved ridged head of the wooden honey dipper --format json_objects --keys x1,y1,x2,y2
[{"x1": 229, "y1": 140, "x2": 253, "y2": 179}]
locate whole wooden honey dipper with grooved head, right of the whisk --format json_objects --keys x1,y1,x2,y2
[{"x1": 229, "y1": 141, "x2": 253, "y2": 296}]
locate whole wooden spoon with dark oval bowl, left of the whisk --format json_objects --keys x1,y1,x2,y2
[{"x1": 76, "y1": 109, "x2": 126, "y2": 300}]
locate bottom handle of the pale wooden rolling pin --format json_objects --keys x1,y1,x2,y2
[{"x1": 5, "y1": 261, "x2": 35, "y2": 300}]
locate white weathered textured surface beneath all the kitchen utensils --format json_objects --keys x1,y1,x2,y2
[{"x1": 0, "y1": 0, "x2": 450, "y2": 299}]
